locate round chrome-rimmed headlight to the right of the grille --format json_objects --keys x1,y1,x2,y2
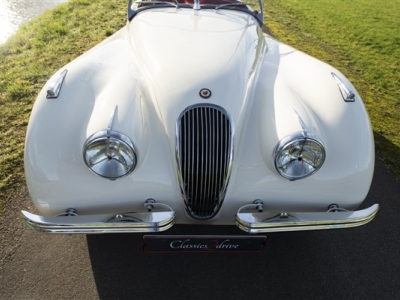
[{"x1": 275, "y1": 133, "x2": 325, "y2": 180}]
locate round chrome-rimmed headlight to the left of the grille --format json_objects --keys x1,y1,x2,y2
[{"x1": 83, "y1": 130, "x2": 136, "y2": 180}]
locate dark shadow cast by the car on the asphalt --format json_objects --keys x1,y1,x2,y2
[{"x1": 87, "y1": 160, "x2": 400, "y2": 300}]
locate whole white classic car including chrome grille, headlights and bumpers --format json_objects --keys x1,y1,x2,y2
[{"x1": 22, "y1": 0, "x2": 378, "y2": 250}]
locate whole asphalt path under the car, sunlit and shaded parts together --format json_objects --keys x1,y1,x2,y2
[{"x1": 0, "y1": 161, "x2": 400, "y2": 300}]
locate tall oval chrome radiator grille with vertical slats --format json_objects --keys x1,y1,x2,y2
[{"x1": 176, "y1": 105, "x2": 233, "y2": 220}]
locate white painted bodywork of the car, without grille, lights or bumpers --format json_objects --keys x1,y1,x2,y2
[{"x1": 25, "y1": 4, "x2": 374, "y2": 224}]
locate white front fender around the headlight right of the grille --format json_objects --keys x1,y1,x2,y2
[{"x1": 228, "y1": 36, "x2": 375, "y2": 211}]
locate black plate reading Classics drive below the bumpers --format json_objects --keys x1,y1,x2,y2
[{"x1": 143, "y1": 235, "x2": 267, "y2": 253}]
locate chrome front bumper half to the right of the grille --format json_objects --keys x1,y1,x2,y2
[{"x1": 235, "y1": 204, "x2": 379, "y2": 233}]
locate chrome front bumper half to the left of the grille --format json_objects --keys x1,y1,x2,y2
[{"x1": 22, "y1": 211, "x2": 175, "y2": 233}]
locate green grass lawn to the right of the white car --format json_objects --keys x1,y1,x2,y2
[{"x1": 264, "y1": 0, "x2": 400, "y2": 176}]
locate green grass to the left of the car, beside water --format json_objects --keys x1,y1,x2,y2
[{"x1": 0, "y1": 0, "x2": 126, "y2": 211}]
